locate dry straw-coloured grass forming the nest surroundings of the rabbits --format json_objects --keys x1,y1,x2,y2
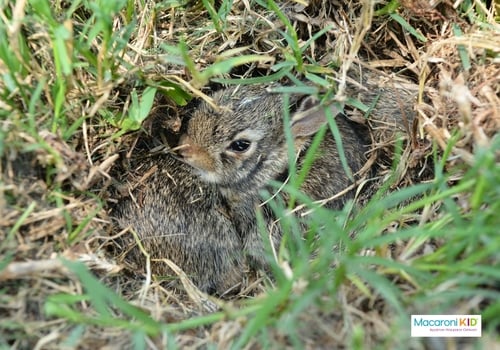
[{"x1": 0, "y1": 0, "x2": 500, "y2": 348}]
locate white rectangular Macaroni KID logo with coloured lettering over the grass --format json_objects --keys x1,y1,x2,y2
[{"x1": 411, "y1": 315, "x2": 481, "y2": 337}]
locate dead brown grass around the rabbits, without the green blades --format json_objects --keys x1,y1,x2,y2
[{"x1": 0, "y1": 0, "x2": 500, "y2": 349}]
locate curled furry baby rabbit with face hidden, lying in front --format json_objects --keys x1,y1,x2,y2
[{"x1": 114, "y1": 154, "x2": 244, "y2": 295}]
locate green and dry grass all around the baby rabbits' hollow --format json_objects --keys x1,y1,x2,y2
[{"x1": 0, "y1": 0, "x2": 500, "y2": 349}]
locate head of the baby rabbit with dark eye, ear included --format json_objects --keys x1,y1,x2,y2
[{"x1": 179, "y1": 85, "x2": 337, "y2": 193}]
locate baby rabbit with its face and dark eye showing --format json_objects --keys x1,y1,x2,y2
[{"x1": 179, "y1": 85, "x2": 367, "y2": 265}]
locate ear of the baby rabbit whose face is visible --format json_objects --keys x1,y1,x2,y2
[{"x1": 291, "y1": 96, "x2": 340, "y2": 137}]
